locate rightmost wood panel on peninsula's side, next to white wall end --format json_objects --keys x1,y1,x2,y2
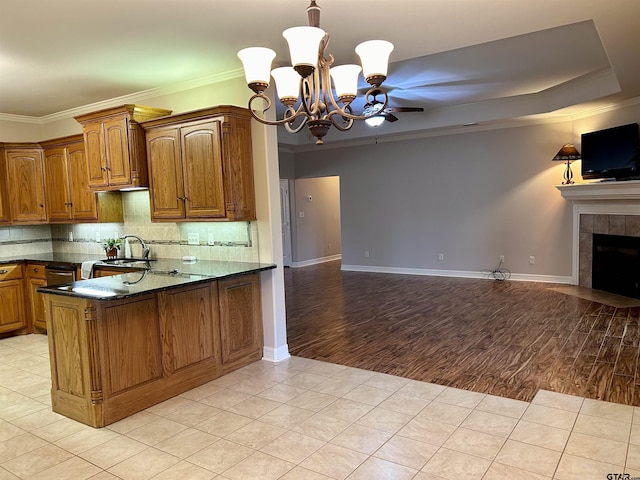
[{"x1": 218, "y1": 273, "x2": 262, "y2": 366}]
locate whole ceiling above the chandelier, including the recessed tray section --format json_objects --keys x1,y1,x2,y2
[{"x1": 0, "y1": 0, "x2": 640, "y2": 142}]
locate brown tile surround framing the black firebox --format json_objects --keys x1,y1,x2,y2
[{"x1": 578, "y1": 214, "x2": 640, "y2": 288}]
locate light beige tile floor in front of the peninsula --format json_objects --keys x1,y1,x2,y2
[{"x1": 0, "y1": 335, "x2": 640, "y2": 480}]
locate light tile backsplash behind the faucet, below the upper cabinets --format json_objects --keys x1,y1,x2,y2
[{"x1": 0, "y1": 190, "x2": 259, "y2": 262}]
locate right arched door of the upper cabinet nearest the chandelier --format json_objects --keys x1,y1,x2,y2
[{"x1": 180, "y1": 121, "x2": 226, "y2": 218}]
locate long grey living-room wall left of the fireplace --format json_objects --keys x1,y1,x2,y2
[{"x1": 295, "y1": 121, "x2": 573, "y2": 281}]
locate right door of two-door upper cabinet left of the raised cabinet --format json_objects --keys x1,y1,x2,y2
[{"x1": 66, "y1": 142, "x2": 98, "y2": 220}]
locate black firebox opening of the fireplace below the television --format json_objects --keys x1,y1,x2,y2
[{"x1": 591, "y1": 233, "x2": 640, "y2": 298}]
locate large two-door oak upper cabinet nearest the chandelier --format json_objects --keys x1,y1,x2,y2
[{"x1": 142, "y1": 106, "x2": 256, "y2": 222}]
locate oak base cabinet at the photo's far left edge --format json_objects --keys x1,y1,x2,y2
[{"x1": 0, "y1": 263, "x2": 27, "y2": 333}]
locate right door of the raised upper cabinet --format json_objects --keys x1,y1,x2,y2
[{"x1": 103, "y1": 117, "x2": 131, "y2": 186}]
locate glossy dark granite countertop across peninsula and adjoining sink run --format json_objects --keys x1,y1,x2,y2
[{"x1": 16, "y1": 253, "x2": 276, "y2": 300}]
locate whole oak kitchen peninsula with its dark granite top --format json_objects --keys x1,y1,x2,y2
[{"x1": 38, "y1": 259, "x2": 275, "y2": 427}]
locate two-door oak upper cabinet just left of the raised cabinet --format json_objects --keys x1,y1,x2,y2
[{"x1": 40, "y1": 135, "x2": 124, "y2": 223}]
